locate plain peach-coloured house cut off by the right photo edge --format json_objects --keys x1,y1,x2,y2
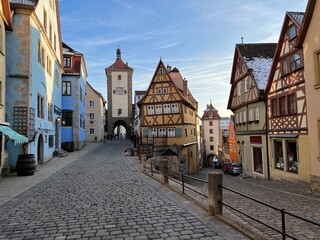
[{"x1": 298, "y1": 0, "x2": 320, "y2": 192}]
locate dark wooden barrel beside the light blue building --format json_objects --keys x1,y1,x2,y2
[{"x1": 16, "y1": 154, "x2": 37, "y2": 176}]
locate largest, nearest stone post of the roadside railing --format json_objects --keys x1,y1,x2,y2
[{"x1": 208, "y1": 172, "x2": 222, "y2": 215}]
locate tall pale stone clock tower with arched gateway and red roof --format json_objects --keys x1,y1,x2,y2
[{"x1": 105, "y1": 48, "x2": 133, "y2": 137}]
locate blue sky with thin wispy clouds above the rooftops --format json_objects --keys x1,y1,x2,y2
[{"x1": 59, "y1": 0, "x2": 307, "y2": 117}]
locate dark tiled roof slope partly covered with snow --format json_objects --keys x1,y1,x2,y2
[{"x1": 237, "y1": 43, "x2": 277, "y2": 90}]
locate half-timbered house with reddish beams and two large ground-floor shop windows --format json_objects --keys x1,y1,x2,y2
[{"x1": 265, "y1": 12, "x2": 310, "y2": 182}]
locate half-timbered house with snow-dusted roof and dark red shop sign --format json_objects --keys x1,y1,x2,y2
[{"x1": 228, "y1": 43, "x2": 277, "y2": 179}]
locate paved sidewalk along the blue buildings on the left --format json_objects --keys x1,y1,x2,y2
[{"x1": 0, "y1": 142, "x2": 105, "y2": 206}]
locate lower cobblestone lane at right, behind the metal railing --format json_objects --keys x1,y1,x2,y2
[{"x1": 181, "y1": 168, "x2": 320, "y2": 239}]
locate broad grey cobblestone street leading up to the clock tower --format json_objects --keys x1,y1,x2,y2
[{"x1": 0, "y1": 140, "x2": 247, "y2": 240}]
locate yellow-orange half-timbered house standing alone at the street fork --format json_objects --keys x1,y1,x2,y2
[{"x1": 139, "y1": 60, "x2": 199, "y2": 174}]
